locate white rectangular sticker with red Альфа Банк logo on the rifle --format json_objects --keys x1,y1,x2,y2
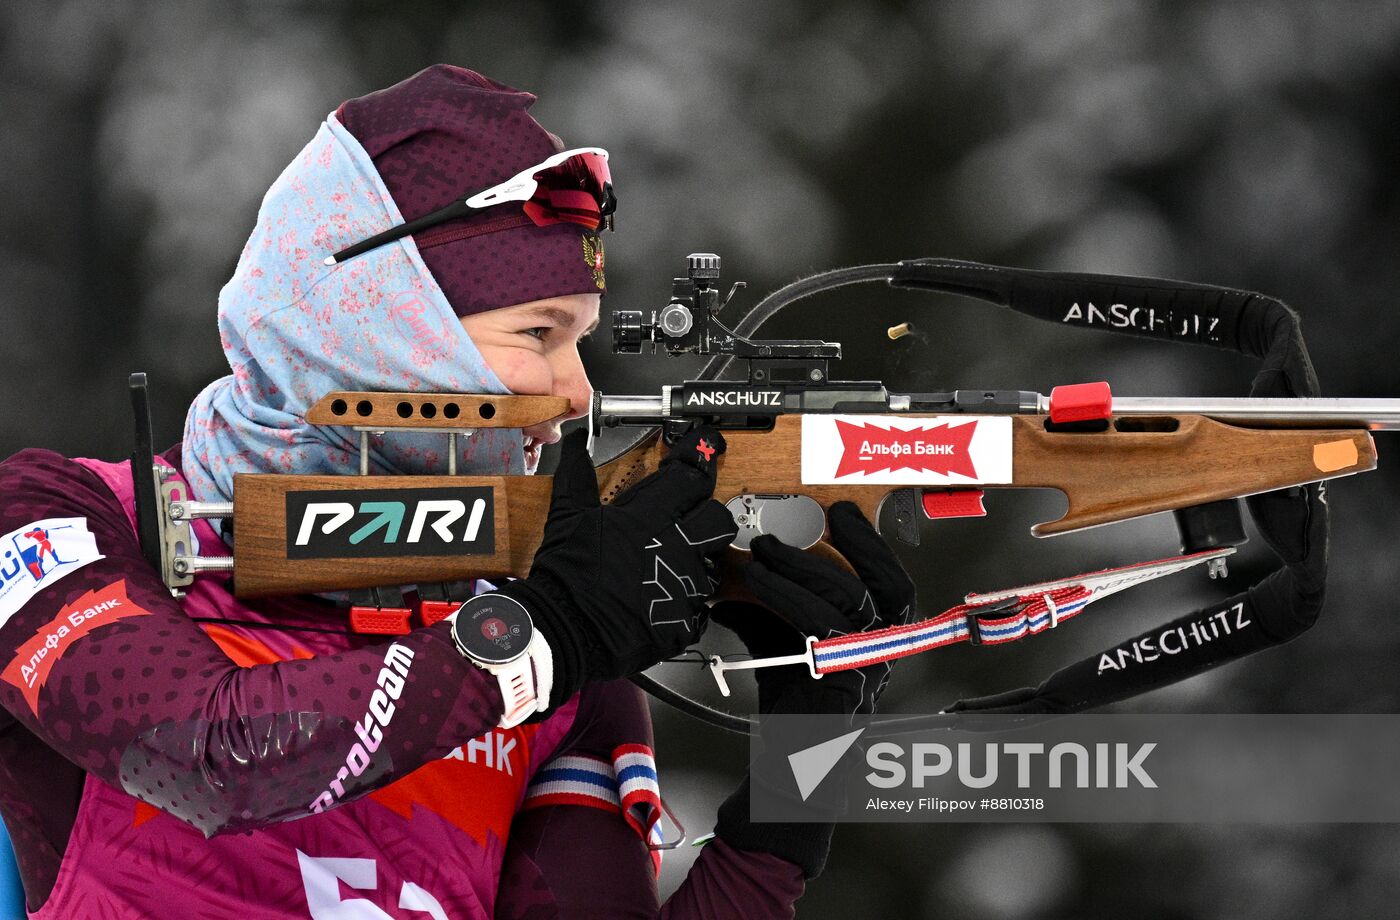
[{"x1": 802, "y1": 414, "x2": 1012, "y2": 485}]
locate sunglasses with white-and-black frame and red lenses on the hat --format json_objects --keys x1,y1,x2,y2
[{"x1": 325, "y1": 147, "x2": 617, "y2": 265}]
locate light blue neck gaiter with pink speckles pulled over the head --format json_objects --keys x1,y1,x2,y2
[{"x1": 182, "y1": 115, "x2": 525, "y2": 501}]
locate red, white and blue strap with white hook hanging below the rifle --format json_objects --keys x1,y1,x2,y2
[{"x1": 710, "y1": 548, "x2": 1235, "y2": 696}]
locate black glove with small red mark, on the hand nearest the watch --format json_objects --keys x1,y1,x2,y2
[{"x1": 498, "y1": 428, "x2": 738, "y2": 709}]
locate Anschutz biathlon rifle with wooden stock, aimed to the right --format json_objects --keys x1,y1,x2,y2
[{"x1": 133, "y1": 253, "x2": 1400, "y2": 733}]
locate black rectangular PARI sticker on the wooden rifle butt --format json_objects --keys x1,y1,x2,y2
[{"x1": 287, "y1": 486, "x2": 496, "y2": 559}]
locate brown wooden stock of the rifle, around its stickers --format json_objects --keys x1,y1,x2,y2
[{"x1": 224, "y1": 411, "x2": 1376, "y2": 597}]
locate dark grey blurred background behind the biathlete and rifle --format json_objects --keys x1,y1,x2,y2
[{"x1": 0, "y1": 0, "x2": 1400, "y2": 920}]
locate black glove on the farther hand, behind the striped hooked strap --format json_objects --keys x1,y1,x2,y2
[{"x1": 711, "y1": 501, "x2": 914, "y2": 878}]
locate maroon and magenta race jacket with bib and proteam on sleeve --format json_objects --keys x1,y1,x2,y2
[{"x1": 0, "y1": 448, "x2": 804, "y2": 920}]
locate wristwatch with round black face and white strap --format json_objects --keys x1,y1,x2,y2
[{"x1": 448, "y1": 594, "x2": 554, "y2": 728}]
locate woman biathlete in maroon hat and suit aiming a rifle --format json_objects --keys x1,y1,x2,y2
[{"x1": 0, "y1": 66, "x2": 913, "y2": 920}]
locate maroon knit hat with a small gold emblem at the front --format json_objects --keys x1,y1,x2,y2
[{"x1": 336, "y1": 64, "x2": 605, "y2": 316}]
